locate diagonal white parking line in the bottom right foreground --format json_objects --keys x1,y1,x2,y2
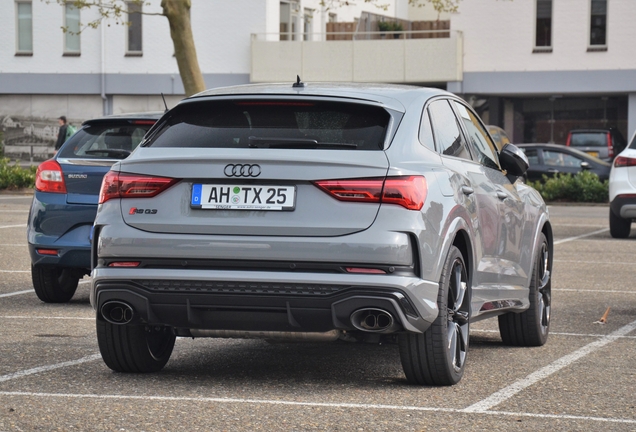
[{"x1": 463, "y1": 321, "x2": 636, "y2": 412}]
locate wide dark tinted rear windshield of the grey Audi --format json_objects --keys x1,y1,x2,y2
[{"x1": 144, "y1": 99, "x2": 390, "y2": 150}]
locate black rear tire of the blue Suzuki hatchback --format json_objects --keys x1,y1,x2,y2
[{"x1": 31, "y1": 265, "x2": 79, "y2": 303}]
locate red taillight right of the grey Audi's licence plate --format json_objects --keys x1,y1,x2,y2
[{"x1": 314, "y1": 176, "x2": 428, "y2": 210}]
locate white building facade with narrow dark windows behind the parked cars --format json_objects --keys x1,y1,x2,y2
[{"x1": 0, "y1": 0, "x2": 636, "y2": 148}]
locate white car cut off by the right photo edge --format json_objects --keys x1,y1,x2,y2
[{"x1": 609, "y1": 133, "x2": 636, "y2": 238}]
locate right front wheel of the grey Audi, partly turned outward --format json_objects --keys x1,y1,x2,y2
[{"x1": 499, "y1": 233, "x2": 552, "y2": 346}]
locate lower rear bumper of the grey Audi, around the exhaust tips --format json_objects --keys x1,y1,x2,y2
[{"x1": 91, "y1": 268, "x2": 438, "y2": 332}]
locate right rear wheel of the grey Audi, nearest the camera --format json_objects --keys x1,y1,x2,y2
[{"x1": 399, "y1": 246, "x2": 470, "y2": 386}]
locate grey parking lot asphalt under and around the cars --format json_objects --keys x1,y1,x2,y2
[{"x1": 0, "y1": 195, "x2": 636, "y2": 431}]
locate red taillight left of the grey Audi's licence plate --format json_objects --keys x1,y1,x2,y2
[{"x1": 99, "y1": 171, "x2": 179, "y2": 204}]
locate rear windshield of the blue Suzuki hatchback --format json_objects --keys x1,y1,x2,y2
[{"x1": 59, "y1": 120, "x2": 153, "y2": 159}]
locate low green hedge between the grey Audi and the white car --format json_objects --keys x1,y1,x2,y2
[{"x1": 528, "y1": 171, "x2": 609, "y2": 203}]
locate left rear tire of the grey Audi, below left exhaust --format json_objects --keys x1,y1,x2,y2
[{"x1": 97, "y1": 317, "x2": 176, "y2": 373}]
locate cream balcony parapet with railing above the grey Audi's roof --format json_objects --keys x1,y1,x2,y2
[{"x1": 250, "y1": 30, "x2": 463, "y2": 84}]
